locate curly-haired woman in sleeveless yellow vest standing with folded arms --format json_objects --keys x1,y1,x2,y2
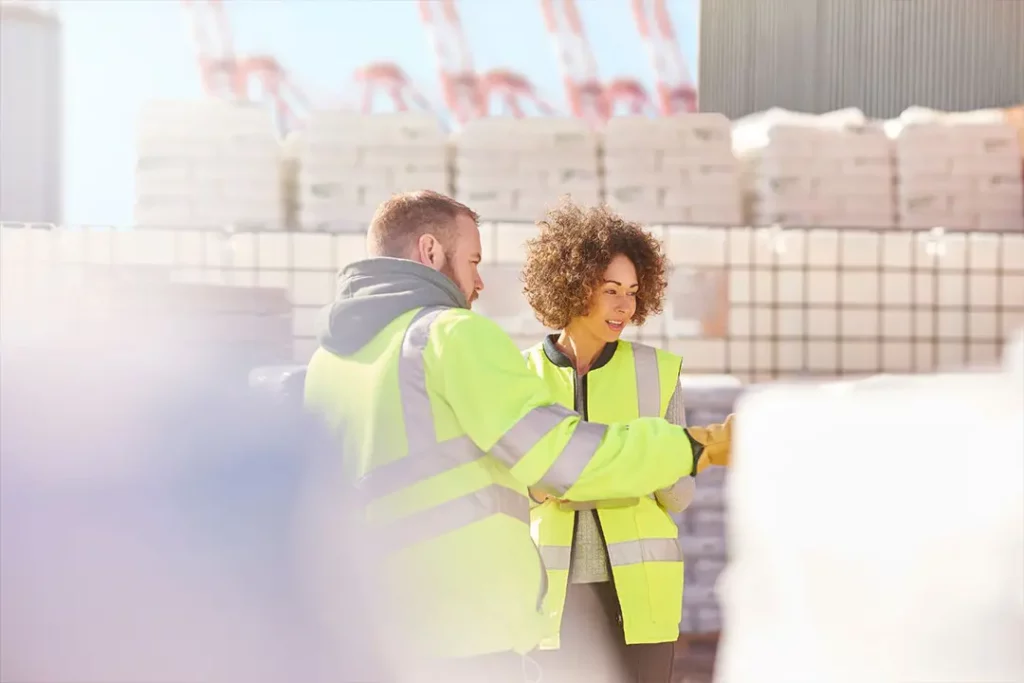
[{"x1": 523, "y1": 204, "x2": 728, "y2": 683}]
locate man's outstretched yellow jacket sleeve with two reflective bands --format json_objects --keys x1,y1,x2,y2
[{"x1": 425, "y1": 311, "x2": 694, "y2": 501}]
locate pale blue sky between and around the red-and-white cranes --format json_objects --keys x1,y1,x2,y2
[{"x1": 61, "y1": 0, "x2": 698, "y2": 224}]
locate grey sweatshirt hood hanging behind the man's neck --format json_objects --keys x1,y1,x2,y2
[{"x1": 316, "y1": 258, "x2": 469, "y2": 355}]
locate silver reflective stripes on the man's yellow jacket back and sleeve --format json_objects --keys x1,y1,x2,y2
[{"x1": 359, "y1": 307, "x2": 607, "y2": 545}]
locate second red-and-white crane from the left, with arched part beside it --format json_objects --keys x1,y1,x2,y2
[{"x1": 420, "y1": 0, "x2": 555, "y2": 125}]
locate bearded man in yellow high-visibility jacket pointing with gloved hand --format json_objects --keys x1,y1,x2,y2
[{"x1": 305, "y1": 191, "x2": 727, "y2": 681}]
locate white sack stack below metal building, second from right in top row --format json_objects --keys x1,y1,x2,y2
[{"x1": 733, "y1": 110, "x2": 895, "y2": 228}]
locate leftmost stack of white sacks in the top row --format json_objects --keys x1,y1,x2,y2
[{"x1": 134, "y1": 100, "x2": 285, "y2": 230}]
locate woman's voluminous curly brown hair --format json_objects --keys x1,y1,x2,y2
[{"x1": 522, "y1": 203, "x2": 669, "y2": 330}]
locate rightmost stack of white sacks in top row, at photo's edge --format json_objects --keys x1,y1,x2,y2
[{"x1": 887, "y1": 109, "x2": 1024, "y2": 231}]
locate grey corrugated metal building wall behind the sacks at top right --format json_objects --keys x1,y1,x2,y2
[{"x1": 699, "y1": 0, "x2": 1024, "y2": 118}]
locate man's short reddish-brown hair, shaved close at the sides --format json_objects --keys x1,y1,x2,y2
[{"x1": 367, "y1": 189, "x2": 479, "y2": 258}]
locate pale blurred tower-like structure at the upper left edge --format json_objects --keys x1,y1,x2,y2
[{"x1": 0, "y1": 2, "x2": 63, "y2": 223}]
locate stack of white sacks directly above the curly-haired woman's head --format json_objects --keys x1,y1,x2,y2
[{"x1": 604, "y1": 114, "x2": 742, "y2": 225}]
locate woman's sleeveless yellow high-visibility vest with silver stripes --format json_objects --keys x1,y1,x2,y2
[{"x1": 524, "y1": 338, "x2": 683, "y2": 649}]
